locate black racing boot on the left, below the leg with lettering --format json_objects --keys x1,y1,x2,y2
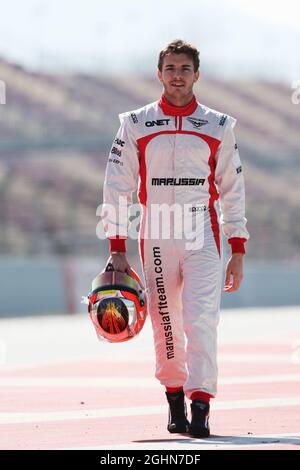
[{"x1": 166, "y1": 390, "x2": 190, "y2": 433}]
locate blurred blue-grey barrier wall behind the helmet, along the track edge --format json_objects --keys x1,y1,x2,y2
[{"x1": 0, "y1": 257, "x2": 300, "y2": 317}]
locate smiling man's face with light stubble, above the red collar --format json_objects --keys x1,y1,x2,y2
[{"x1": 157, "y1": 54, "x2": 199, "y2": 98}]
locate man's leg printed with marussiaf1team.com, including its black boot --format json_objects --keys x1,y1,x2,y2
[{"x1": 143, "y1": 240, "x2": 189, "y2": 433}]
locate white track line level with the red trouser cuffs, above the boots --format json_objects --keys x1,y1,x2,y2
[{"x1": 0, "y1": 374, "x2": 300, "y2": 389}]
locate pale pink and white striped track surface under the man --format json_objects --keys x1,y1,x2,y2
[{"x1": 0, "y1": 307, "x2": 300, "y2": 450}]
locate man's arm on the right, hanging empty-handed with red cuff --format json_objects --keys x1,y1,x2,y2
[{"x1": 215, "y1": 117, "x2": 249, "y2": 292}]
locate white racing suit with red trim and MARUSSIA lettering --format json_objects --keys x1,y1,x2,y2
[{"x1": 103, "y1": 96, "x2": 249, "y2": 398}]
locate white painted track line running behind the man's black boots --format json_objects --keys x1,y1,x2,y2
[{"x1": 0, "y1": 397, "x2": 300, "y2": 424}]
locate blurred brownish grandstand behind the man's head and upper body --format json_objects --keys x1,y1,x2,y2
[{"x1": 0, "y1": 60, "x2": 300, "y2": 260}]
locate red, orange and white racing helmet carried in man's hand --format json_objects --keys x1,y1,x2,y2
[{"x1": 88, "y1": 263, "x2": 147, "y2": 343}]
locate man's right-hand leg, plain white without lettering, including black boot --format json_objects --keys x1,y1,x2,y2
[{"x1": 182, "y1": 238, "x2": 222, "y2": 437}]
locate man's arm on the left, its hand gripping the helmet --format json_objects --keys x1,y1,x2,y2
[{"x1": 102, "y1": 115, "x2": 139, "y2": 272}]
